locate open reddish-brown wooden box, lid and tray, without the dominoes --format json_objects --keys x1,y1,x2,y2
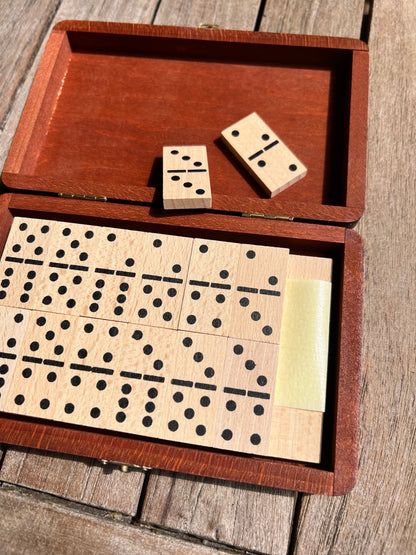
[{"x1": 0, "y1": 21, "x2": 368, "y2": 495}]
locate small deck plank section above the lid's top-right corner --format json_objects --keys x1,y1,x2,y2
[{"x1": 260, "y1": 0, "x2": 364, "y2": 38}]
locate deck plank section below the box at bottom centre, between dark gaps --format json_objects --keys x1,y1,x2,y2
[{"x1": 141, "y1": 472, "x2": 296, "y2": 555}]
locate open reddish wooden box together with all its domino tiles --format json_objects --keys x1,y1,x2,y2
[{"x1": 0, "y1": 21, "x2": 368, "y2": 495}]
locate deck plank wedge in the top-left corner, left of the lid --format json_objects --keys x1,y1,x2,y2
[{"x1": 0, "y1": 0, "x2": 58, "y2": 130}]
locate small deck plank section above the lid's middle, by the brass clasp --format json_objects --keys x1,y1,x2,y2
[{"x1": 154, "y1": 0, "x2": 261, "y2": 30}]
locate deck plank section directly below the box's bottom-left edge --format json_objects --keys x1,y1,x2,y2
[{"x1": 0, "y1": 448, "x2": 144, "y2": 516}]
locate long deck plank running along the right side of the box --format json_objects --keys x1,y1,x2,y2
[{"x1": 295, "y1": 0, "x2": 416, "y2": 554}]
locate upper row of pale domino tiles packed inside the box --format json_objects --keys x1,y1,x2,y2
[{"x1": 0, "y1": 218, "x2": 289, "y2": 343}]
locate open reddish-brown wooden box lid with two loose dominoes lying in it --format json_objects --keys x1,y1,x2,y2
[{"x1": 2, "y1": 21, "x2": 368, "y2": 224}]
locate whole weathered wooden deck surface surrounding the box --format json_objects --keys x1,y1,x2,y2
[{"x1": 0, "y1": 0, "x2": 416, "y2": 554}]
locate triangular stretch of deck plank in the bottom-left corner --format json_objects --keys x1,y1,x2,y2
[{"x1": 0, "y1": 489, "x2": 218, "y2": 555}]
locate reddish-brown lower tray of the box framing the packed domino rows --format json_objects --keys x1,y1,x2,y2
[{"x1": 0, "y1": 194, "x2": 362, "y2": 495}]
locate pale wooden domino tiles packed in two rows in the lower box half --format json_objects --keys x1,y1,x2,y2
[{"x1": 0, "y1": 217, "x2": 331, "y2": 462}]
